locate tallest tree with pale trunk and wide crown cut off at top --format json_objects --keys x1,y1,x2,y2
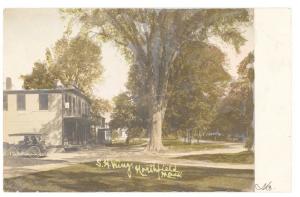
[{"x1": 63, "y1": 9, "x2": 250, "y2": 151}]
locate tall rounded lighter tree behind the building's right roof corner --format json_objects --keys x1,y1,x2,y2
[{"x1": 46, "y1": 36, "x2": 103, "y2": 94}]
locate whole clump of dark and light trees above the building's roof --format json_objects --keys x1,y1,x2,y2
[{"x1": 21, "y1": 36, "x2": 103, "y2": 95}]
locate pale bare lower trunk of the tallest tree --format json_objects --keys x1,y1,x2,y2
[{"x1": 147, "y1": 110, "x2": 165, "y2": 152}]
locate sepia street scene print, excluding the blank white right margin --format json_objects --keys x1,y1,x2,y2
[{"x1": 3, "y1": 8, "x2": 254, "y2": 192}]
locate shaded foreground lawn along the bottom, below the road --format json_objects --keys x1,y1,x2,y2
[{"x1": 4, "y1": 162, "x2": 254, "y2": 192}]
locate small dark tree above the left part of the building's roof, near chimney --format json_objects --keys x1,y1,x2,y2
[{"x1": 21, "y1": 62, "x2": 57, "y2": 89}]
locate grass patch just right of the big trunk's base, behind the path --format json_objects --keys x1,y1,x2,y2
[{"x1": 163, "y1": 139, "x2": 225, "y2": 152}]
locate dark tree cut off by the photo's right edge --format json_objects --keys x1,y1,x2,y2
[{"x1": 214, "y1": 52, "x2": 254, "y2": 149}]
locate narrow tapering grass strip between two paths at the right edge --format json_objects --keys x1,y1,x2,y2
[{"x1": 177, "y1": 151, "x2": 254, "y2": 164}]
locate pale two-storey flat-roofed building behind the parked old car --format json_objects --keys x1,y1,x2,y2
[{"x1": 3, "y1": 88, "x2": 91, "y2": 146}]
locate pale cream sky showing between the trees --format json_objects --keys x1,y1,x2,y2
[{"x1": 3, "y1": 9, "x2": 254, "y2": 99}]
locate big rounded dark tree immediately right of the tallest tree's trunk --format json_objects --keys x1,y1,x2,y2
[{"x1": 164, "y1": 42, "x2": 230, "y2": 143}]
